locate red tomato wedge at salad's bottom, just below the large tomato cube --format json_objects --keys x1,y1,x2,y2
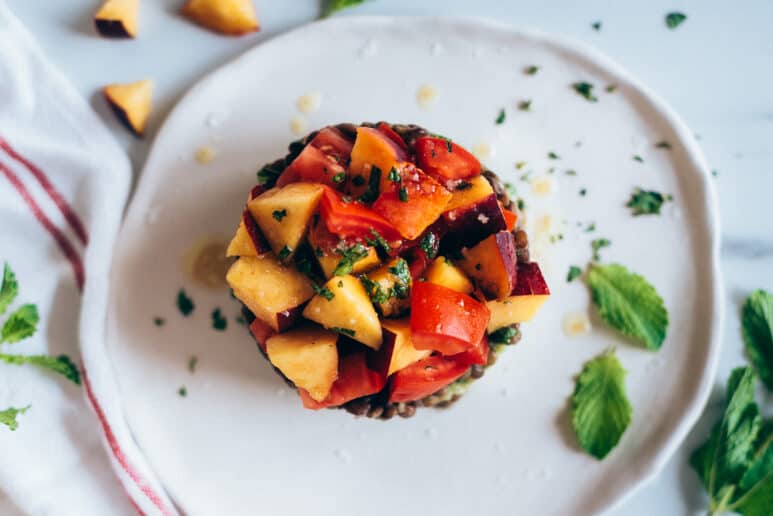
[{"x1": 389, "y1": 355, "x2": 470, "y2": 403}]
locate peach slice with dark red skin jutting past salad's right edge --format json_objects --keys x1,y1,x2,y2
[{"x1": 486, "y1": 262, "x2": 550, "y2": 333}]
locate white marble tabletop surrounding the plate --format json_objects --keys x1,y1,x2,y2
[{"x1": 7, "y1": 0, "x2": 773, "y2": 516}]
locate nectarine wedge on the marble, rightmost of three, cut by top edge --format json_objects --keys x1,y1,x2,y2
[{"x1": 182, "y1": 0, "x2": 260, "y2": 36}]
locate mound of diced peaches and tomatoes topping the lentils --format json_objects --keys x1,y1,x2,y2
[{"x1": 227, "y1": 122, "x2": 550, "y2": 416}]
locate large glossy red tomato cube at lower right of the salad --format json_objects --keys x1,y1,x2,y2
[{"x1": 411, "y1": 281, "x2": 490, "y2": 355}]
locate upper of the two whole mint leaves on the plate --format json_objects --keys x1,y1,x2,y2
[{"x1": 586, "y1": 264, "x2": 668, "y2": 351}]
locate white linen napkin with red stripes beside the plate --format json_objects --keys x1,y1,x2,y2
[{"x1": 0, "y1": 4, "x2": 176, "y2": 516}]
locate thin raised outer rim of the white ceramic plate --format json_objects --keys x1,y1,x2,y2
[{"x1": 116, "y1": 15, "x2": 726, "y2": 512}]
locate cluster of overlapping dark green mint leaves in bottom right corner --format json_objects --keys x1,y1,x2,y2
[{"x1": 690, "y1": 367, "x2": 773, "y2": 516}]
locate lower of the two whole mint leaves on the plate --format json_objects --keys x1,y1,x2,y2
[{"x1": 572, "y1": 351, "x2": 633, "y2": 460}]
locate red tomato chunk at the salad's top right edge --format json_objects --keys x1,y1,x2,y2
[{"x1": 416, "y1": 136, "x2": 481, "y2": 182}]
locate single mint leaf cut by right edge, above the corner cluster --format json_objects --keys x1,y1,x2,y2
[{"x1": 741, "y1": 290, "x2": 773, "y2": 391}]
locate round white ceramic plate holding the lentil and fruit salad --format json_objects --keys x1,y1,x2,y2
[{"x1": 108, "y1": 18, "x2": 721, "y2": 516}]
